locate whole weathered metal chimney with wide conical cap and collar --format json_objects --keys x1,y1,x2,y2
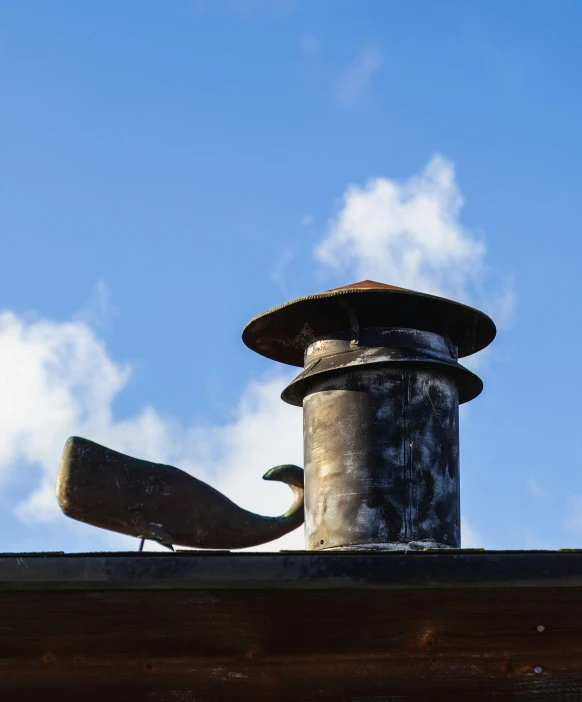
[{"x1": 243, "y1": 280, "x2": 495, "y2": 550}]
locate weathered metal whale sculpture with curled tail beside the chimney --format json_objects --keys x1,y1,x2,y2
[{"x1": 57, "y1": 436, "x2": 304, "y2": 549}]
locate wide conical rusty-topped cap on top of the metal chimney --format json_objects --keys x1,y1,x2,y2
[{"x1": 242, "y1": 280, "x2": 496, "y2": 367}]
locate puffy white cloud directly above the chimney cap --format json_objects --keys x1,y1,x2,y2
[{"x1": 315, "y1": 154, "x2": 515, "y2": 323}]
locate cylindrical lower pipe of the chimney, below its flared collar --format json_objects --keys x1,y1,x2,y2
[{"x1": 303, "y1": 366, "x2": 460, "y2": 549}]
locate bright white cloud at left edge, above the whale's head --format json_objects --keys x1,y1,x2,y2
[{"x1": 0, "y1": 312, "x2": 129, "y2": 492}]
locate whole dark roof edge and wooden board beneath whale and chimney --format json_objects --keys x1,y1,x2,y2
[{"x1": 0, "y1": 551, "x2": 582, "y2": 702}]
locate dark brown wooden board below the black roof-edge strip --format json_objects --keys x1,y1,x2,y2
[{"x1": 0, "y1": 587, "x2": 582, "y2": 702}]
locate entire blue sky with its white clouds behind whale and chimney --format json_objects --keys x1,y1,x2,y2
[{"x1": 0, "y1": 0, "x2": 582, "y2": 550}]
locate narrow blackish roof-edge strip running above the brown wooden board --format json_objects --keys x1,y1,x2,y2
[{"x1": 5, "y1": 549, "x2": 582, "y2": 592}]
